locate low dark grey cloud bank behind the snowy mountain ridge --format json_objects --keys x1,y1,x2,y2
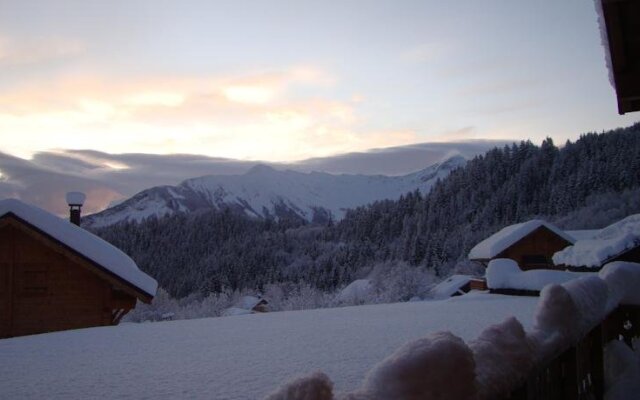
[{"x1": 0, "y1": 141, "x2": 504, "y2": 215}]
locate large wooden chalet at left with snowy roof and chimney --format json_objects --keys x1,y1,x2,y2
[{"x1": 0, "y1": 199, "x2": 157, "y2": 338}]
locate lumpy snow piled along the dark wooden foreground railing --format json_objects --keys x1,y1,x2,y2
[{"x1": 267, "y1": 262, "x2": 640, "y2": 400}]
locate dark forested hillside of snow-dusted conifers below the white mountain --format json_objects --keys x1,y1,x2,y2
[{"x1": 94, "y1": 124, "x2": 640, "y2": 301}]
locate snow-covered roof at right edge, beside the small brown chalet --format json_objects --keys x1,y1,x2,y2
[{"x1": 553, "y1": 214, "x2": 640, "y2": 268}]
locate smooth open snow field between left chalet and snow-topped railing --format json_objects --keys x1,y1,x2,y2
[{"x1": 0, "y1": 293, "x2": 538, "y2": 399}]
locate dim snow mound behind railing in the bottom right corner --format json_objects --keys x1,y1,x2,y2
[{"x1": 604, "y1": 340, "x2": 640, "y2": 400}]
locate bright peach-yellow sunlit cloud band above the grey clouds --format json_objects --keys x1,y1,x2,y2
[{"x1": 0, "y1": 66, "x2": 410, "y2": 161}]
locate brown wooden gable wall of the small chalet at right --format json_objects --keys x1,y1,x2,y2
[{"x1": 496, "y1": 227, "x2": 571, "y2": 270}]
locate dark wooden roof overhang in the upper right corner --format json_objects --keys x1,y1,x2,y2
[{"x1": 598, "y1": 0, "x2": 640, "y2": 114}]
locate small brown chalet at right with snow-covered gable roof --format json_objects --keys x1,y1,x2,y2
[{"x1": 469, "y1": 220, "x2": 574, "y2": 270}]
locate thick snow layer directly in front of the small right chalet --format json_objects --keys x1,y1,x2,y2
[{"x1": 486, "y1": 258, "x2": 585, "y2": 291}]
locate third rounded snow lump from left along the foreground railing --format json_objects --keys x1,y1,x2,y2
[{"x1": 469, "y1": 317, "x2": 536, "y2": 399}]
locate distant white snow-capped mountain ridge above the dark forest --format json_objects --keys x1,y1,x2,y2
[{"x1": 83, "y1": 156, "x2": 466, "y2": 228}]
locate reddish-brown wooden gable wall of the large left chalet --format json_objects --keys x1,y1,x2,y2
[{"x1": 0, "y1": 214, "x2": 146, "y2": 338}]
